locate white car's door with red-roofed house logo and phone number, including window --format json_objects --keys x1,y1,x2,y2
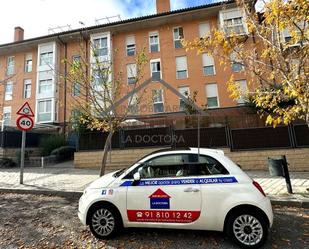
[{"x1": 124, "y1": 154, "x2": 202, "y2": 227}]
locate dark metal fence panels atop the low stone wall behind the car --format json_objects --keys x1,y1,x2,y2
[{"x1": 79, "y1": 124, "x2": 309, "y2": 150}]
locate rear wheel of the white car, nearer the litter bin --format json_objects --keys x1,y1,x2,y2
[{"x1": 226, "y1": 209, "x2": 268, "y2": 248}]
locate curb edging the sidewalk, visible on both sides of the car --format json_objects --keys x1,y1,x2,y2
[{"x1": 0, "y1": 188, "x2": 309, "y2": 208}]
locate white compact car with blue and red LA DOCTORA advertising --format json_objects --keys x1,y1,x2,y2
[{"x1": 78, "y1": 148, "x2": 273, "y2": 248}]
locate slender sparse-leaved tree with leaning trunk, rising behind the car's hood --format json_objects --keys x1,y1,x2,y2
[{"x1": 62, "y1": 36, "x2": 147, "y2": 176}]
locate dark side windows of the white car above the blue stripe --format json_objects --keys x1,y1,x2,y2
[{"x1": 125, "y1": 154, "x2": 228, "y2": 179}]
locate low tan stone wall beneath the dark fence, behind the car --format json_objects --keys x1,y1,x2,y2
[{"x1": 74, "y1": 148, "x2": 309, "y2": 171}]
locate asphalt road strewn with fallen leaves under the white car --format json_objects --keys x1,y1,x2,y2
[{"x1": 0, "y1": 194, "x2": 309, "y2": 249}]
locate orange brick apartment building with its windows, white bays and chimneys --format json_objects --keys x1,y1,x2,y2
[{"x1": 0, "y1": 0, "x2": 252, "y2": 128}]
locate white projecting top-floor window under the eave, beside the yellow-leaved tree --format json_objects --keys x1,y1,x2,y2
[{"x1": 220, "y1": 9, "x2": 247, "y2": 35}]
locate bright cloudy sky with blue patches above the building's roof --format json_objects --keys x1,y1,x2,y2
[{"x1": 0, "y1": 0, "x2": 218, "y2": 44}]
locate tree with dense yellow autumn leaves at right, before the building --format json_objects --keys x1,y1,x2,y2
[{"x1": 183, "y1": 0, "x2": 309, "y2": 127}]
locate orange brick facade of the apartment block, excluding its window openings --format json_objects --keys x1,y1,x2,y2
[{"x1": 0, "y1": 0, "x2": 252, "y2": 127}]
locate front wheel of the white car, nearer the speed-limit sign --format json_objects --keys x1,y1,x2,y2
[{"x1": 89, "y1": 205, "x2": 122, "y2": 239}]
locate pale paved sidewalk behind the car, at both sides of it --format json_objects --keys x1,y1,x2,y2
[{"x1": 0, "y1": 163, "x2": 309, "y2": 201}]
